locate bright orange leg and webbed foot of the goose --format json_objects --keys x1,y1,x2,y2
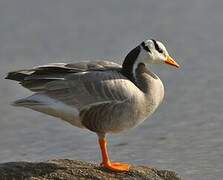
[{"x1": 99, "y1": 139, "x2": 129, "y2": 172}]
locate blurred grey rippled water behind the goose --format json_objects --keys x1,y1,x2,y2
[{"x1": 0, "y1": 0, "x2": 223, "y2": 180}]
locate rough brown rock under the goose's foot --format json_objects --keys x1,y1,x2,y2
[{"x1": 0, "y1": 159, "x2": 180, "y2": 180}]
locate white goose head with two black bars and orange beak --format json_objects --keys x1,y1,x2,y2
[{"x1": 137, "y1": 39, "x2": 180, "y2": 68}]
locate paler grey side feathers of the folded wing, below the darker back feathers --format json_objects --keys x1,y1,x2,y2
[{"x1": 43, "y1": 70, "x2": 141, "y2": 109}]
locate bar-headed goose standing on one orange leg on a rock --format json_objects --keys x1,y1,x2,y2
[{"x1": 6, "y1": 39, "x2": 179, "y2": 171}]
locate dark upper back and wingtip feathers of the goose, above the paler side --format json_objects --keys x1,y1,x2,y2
[{"x1": 5, "y1": 61, "x2": 121, "y2": 92}]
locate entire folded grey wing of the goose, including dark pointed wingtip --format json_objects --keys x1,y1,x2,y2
[{"x1": 6, "y1": 61, "x2": 143, "y2": 109}]
